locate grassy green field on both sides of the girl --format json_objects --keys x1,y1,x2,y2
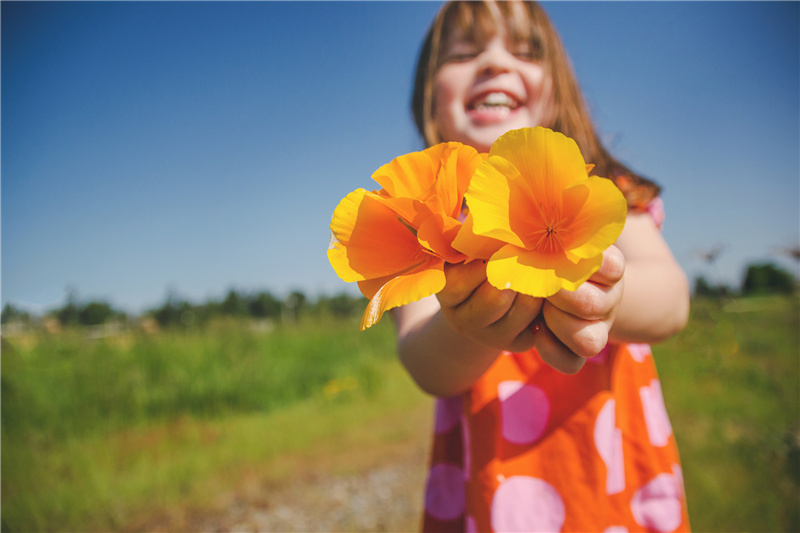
[{"x1": 2, "y1": 297, "x2": 800, "y2": 531}]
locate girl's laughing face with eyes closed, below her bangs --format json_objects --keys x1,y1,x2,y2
[{"x1": 434, "y1": 28, "x2": 552, "y2": 152}]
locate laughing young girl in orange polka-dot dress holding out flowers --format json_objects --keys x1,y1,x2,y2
[{"x1": 395, "y1": 2, "x2": 689, "y2": 532}]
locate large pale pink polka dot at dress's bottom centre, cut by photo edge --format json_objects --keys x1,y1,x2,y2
[{"x1": 491, "y1": 476, "x2": 566, "y2": 533}]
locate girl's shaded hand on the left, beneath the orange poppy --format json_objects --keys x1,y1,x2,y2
[{"x1": 437, "y1": 260, "x2": 544, "y2": 352}]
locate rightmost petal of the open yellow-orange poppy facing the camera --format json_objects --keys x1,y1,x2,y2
[{"x1": 564, "y1": 176, "x2": 628, "y2": 258}]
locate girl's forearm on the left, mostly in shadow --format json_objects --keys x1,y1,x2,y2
[{"x1": 395, "y1": 298, "x2": 500, "y2": 397}]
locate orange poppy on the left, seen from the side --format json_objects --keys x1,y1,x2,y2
[{"x1": 328, "y1": 143, "x2": 484, "y2": 329}]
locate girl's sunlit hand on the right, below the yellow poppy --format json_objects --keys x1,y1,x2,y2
[{"x1": 534, "y1": 246, "x2": 625, "y2": 374}]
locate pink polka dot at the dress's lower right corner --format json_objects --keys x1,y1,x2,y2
[{"x1": 631, "y1": 474, "x2": 683, "y2": 533}]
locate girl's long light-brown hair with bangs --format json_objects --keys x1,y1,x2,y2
[{"x1": 411, "y1": 1, "x2": 661, "y2": 208}]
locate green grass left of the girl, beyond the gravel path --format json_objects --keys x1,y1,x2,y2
[{"x1": 2, "y1": 321, "x2": 427, "y2": 531}]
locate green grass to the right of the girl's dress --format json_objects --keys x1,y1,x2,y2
[{"x1": 654, "y1": 297, "x2": 800, "y2": 532}]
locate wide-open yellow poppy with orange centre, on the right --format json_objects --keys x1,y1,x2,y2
[{"x1": 453, "y1": 128, "x2": 627, "y2": 298}]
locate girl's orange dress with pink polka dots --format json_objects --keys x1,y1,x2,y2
[{"x1": 423, "y1": 198, "x2": 689, "y2": 533}]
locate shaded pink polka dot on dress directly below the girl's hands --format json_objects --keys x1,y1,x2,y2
[{"x1": 497, "y1": 381, "x2": 550, "y2": 444}]
